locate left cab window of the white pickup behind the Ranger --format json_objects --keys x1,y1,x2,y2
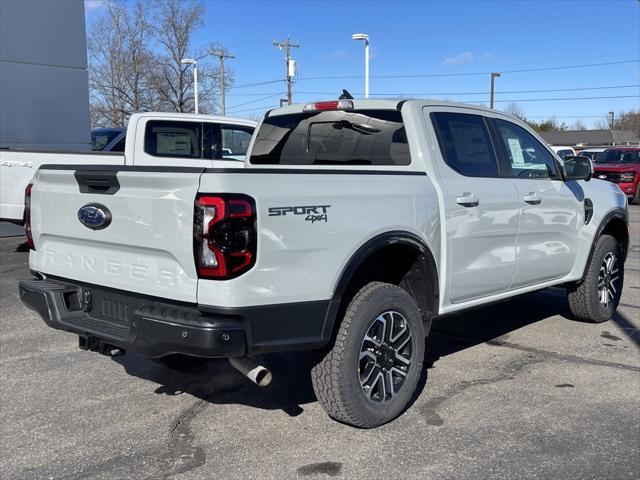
[{"x1": 144, "y1": 120, "x2": 202, "y2": 158}]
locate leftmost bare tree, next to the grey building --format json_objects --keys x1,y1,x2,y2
[{"x1": 87, "y1": 0, "x2": 154, "y2": 126}]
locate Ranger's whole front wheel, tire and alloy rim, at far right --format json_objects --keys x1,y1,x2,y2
[{"x1": 567, "y1": 235, "x2": 624, "y2": 323}]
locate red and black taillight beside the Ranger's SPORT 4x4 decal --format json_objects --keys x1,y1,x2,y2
[{"x1": 193, "y1": 194, "x2": 257, "y2": 280}]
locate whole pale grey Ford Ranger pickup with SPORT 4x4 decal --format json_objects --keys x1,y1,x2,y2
[{"x1": 20, "y1": 100, "x2": 629, "y2": 427}]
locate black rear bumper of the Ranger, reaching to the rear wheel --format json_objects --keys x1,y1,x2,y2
[{"x1": 19, "y1": 278, "x2": 333, "y2": 357}]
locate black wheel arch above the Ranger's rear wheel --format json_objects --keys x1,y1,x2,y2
[{"x1": 326, "y1": 231, "x2": 439, "y2": 333}]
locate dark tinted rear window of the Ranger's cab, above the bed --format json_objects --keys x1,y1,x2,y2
[{"x1": 250, "y1": 110, "x2": 411, "y2": 166}]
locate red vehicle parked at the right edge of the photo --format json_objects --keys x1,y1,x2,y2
[{"x1": 594, "y1": 147, "x2": 640, "y2": 203}]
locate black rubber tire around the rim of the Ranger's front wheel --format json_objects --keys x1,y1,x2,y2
[{"x1": 567, "y1": 235, "x2": 624, "y2": 323}]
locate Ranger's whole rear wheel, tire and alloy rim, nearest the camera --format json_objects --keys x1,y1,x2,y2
[{"x1": 311, "y1": 282, "x2": 425, "y2": 428}]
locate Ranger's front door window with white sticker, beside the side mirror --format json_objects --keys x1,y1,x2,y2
[{"x1": 494, "y1": 119, "x2": 557, "y2": 178}]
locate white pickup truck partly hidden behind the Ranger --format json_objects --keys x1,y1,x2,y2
[{"x1": 0, "y1": 113, "x2": 256, "y2": 223}]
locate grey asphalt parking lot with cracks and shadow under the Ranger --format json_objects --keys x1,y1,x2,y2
[{"x1": 0, "y1": 206, "x2": 640, "y2": 480}]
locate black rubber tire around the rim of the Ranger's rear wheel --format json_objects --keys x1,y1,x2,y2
[{"x1": 311, "y1": 282, "x2": 425, "y2": 428}]
